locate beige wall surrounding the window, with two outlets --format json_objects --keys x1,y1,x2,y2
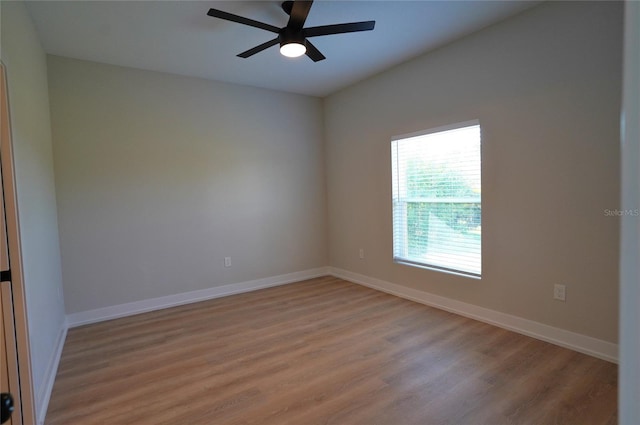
[{"x1": 325, "y1": 2, "x2": 622, "y2": 342}]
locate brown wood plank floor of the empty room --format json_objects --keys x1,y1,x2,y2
[{"x1": 46, "y1": 277, "x2": 617, "y2": 425}]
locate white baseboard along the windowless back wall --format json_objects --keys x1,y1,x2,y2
[{"x1": 67, "y1": 267, "x2": 329, "y2": 328}]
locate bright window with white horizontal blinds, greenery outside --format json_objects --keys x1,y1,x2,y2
[{"x1": 391, "y1": 121, "x2": 482, "y2": 277}]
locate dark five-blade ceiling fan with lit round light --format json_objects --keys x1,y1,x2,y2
[{"x1": 207, "y1": 0, "x2": 376, "y2": 62}]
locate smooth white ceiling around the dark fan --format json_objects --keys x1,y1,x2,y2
[{"x1": 27, "y1": 0, "x2": 538, "y2": 96}]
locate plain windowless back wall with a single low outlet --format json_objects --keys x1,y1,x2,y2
[{"x1": 48, "y1": 56, "x2": 327, "y2": 313}]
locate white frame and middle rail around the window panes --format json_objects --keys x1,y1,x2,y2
[{"x1": 391, "y1": 120, "x2": 482, "y2": 279}]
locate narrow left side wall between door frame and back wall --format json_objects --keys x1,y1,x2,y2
[{"x1": 0, "y1": 1, "x2": 65, "y2": 414}]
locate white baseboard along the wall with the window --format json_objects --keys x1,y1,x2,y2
[{"x1": 329, "y1": 267, "x2": 618, "y2": 363}]
